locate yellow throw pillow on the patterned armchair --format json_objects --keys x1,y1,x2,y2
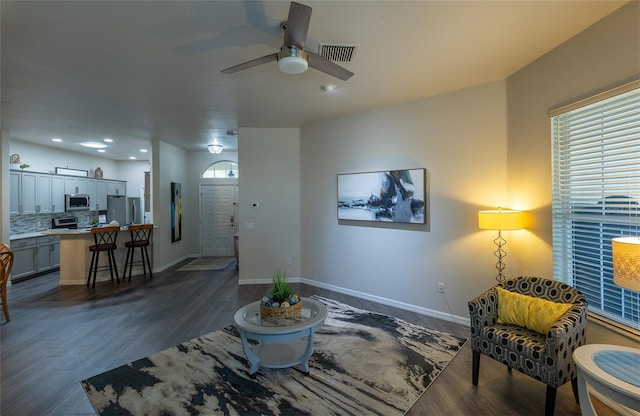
[{"x1": 496, "y1": 287, "x2": 573, "y2": 335}]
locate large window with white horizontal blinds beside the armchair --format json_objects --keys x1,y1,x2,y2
[{"x1": 551, "y1": 82, "x2": 640, "y2": 331}]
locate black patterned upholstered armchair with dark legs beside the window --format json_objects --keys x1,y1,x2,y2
[{"x1": 469, "y1": 276, "x2": 587, "y2": 415}]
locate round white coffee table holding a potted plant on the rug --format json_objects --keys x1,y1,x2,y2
[{"x1": 233, "y1": 298, "x2": 327, "y2": 374}]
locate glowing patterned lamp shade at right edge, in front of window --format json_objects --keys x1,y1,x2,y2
[{"x1": 611, "y1": 237, "x2": 640, "y2": 292}]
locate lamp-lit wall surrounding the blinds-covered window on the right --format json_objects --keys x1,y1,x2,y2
[{"x1": 507, "y1": 2, "x2": 640, "y2": 346}]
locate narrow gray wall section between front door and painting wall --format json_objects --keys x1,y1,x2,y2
[{"x1": 238, "y1": 128, "x2": 307, "y2": 284}]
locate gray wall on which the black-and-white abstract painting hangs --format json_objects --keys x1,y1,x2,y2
[{"x1": 301, "y1": 81, "x2": 510, "y2": 319}]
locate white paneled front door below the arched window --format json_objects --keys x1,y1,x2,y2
[{"x1": 200, "y1": 185, "x2": 236, "y2": 257}]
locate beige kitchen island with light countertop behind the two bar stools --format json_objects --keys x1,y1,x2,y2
[{"x1": 41, "y1": 227, "x2": 153, "y2": 285}]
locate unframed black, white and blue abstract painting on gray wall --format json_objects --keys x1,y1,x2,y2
[{"x1": 338, "y1": 168, "x2": 426, "y2": 224}]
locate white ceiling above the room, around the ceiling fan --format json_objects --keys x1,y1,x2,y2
[{"x1": 0, "y1": 0, "x2": 626, "y2": 160}]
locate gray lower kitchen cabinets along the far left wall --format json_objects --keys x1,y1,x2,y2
[{"x1": 10, "y1": 235, "x2": 60, "y2": 281}]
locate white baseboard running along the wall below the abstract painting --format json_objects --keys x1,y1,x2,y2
[{"x1": 238, "y1": 277, "x2": 471, "y2": 327}]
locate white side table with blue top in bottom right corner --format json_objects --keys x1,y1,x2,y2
[{"x1": 573, "y1": 344, "x2": 640, "y2": 416}]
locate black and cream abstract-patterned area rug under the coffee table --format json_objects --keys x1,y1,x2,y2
[{"x1": 81, "y1": 296, "x2": 467, "y2": 416}]
